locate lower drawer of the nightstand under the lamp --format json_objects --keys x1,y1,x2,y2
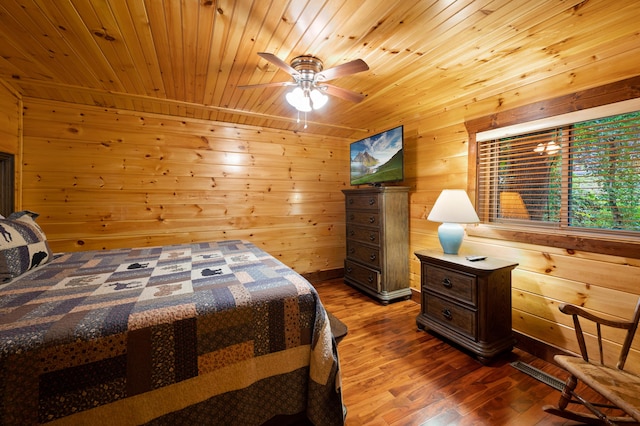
[{"x1": 422, "y1": 292, "x2": 477, "y2": 340}]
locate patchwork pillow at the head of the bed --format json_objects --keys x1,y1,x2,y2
[{"x1": 0, "y1": 210, "x2": 52, "y2": 283}]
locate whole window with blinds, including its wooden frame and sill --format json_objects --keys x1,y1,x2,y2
[{"x1": 465, "y1": 76, "x2": 640, "y2": 259}]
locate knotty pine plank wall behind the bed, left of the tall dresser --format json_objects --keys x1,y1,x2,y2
[{"x1": 23, "y1": 99, "x2": 348, "y2": 273}]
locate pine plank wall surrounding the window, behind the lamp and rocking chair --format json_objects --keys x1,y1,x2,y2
[{"x1": 405, "y1": 61, "x2": 640, "y2": 372}]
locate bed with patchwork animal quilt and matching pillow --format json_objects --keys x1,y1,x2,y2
[{"x1": 0, "y1": 212, "x2": 343, "y2": 426}]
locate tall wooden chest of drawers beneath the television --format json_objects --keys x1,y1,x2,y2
[{"x1": 342, "y1": 186, "x2": 411, "y2": 304}]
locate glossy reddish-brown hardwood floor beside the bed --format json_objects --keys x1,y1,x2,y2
[{"x1": 314, "y1": 279, "x2": 608, "y2": 426}]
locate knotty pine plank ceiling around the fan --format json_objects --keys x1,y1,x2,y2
[{"x1": 0, "y1": 0, "x2": 640, "y2": 136}]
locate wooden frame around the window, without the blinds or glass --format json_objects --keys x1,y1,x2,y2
[{"x1": 465, "y1": 76, "x2": 640, "y2": 259}]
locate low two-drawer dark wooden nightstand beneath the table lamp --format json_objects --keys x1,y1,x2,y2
[{"x1": 415, "y1": 251, "x2": 518, "y2": 364}]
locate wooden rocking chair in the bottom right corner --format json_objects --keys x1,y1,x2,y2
[{"x1": 543, "y1": 299, "x2": 640, "y2": 425}]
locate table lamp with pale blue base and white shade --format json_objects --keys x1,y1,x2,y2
[{"x1": 427, "y1": 189, "x2": 480, "y2": 254}]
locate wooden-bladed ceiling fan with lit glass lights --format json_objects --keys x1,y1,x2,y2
[{"x1": 238, "y1": 52, "x2": 369, "y2": 112}]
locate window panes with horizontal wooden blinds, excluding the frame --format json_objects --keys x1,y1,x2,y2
[{"x1": 477, "y1": 111, "x2": 640, "y2": 235}]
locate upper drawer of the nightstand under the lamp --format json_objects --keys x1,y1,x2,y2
[{"x1": 422, "y1": 263, "x2": 478, "y2": 306}]
